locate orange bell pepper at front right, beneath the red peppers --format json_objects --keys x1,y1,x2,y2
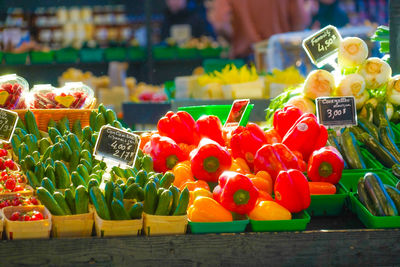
[{"x1": 249, "y1": 201, "x2": 292, "y2": 221}]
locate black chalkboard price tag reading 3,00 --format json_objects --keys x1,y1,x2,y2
[{"x1": 316, "y1": 96, "x2": 357, "y2": 128}]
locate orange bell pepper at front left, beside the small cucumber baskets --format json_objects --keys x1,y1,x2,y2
[{"x1": 188, "y1": 197, "x2": 233, "y2": 222}]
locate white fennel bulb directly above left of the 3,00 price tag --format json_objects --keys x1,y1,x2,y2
[{"x1": 303, "y1": 70, "x2": 335, "y2": 100}]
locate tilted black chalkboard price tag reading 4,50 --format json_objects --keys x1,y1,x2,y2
[{"x1": 303, "y1": 25, "x2": 342, "y2": 68}]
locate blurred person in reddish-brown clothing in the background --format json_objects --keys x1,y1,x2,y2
[{"x1": 207, "y1": 0, "x2": 311, "y2": 58}]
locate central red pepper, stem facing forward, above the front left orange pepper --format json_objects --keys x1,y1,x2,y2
[{"x1": 190, "y1": 138, "x2": 232, "y2": 182}]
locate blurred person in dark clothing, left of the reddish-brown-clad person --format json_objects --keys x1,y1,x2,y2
[{"x1": 161, "y1": 0, "x2": 210, "y2": 40}]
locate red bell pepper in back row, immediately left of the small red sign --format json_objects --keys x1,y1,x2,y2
[{"x1": 196, "y1": 115, "x2": 225, "y2": 146}]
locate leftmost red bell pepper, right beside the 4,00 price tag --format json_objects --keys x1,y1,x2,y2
[{"x1": 143, "y1": 134, "x2": 186, "y2": 172}]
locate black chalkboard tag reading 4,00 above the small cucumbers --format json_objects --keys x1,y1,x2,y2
[{"x1": 93, "y1": 125, "x2": 140, "y2": 167}]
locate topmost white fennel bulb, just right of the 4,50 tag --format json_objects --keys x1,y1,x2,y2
[{"x1": 338, "y1": 37, "x2": 368, "y2": 68}]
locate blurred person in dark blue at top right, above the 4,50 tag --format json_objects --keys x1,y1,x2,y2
[{"x1": 311, "y1": 0, "x2": 349, "y2": 29}]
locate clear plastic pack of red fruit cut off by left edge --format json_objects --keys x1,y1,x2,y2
[{"x1": 0, "y1": 74, "x2": 29, "y2": 109}]
